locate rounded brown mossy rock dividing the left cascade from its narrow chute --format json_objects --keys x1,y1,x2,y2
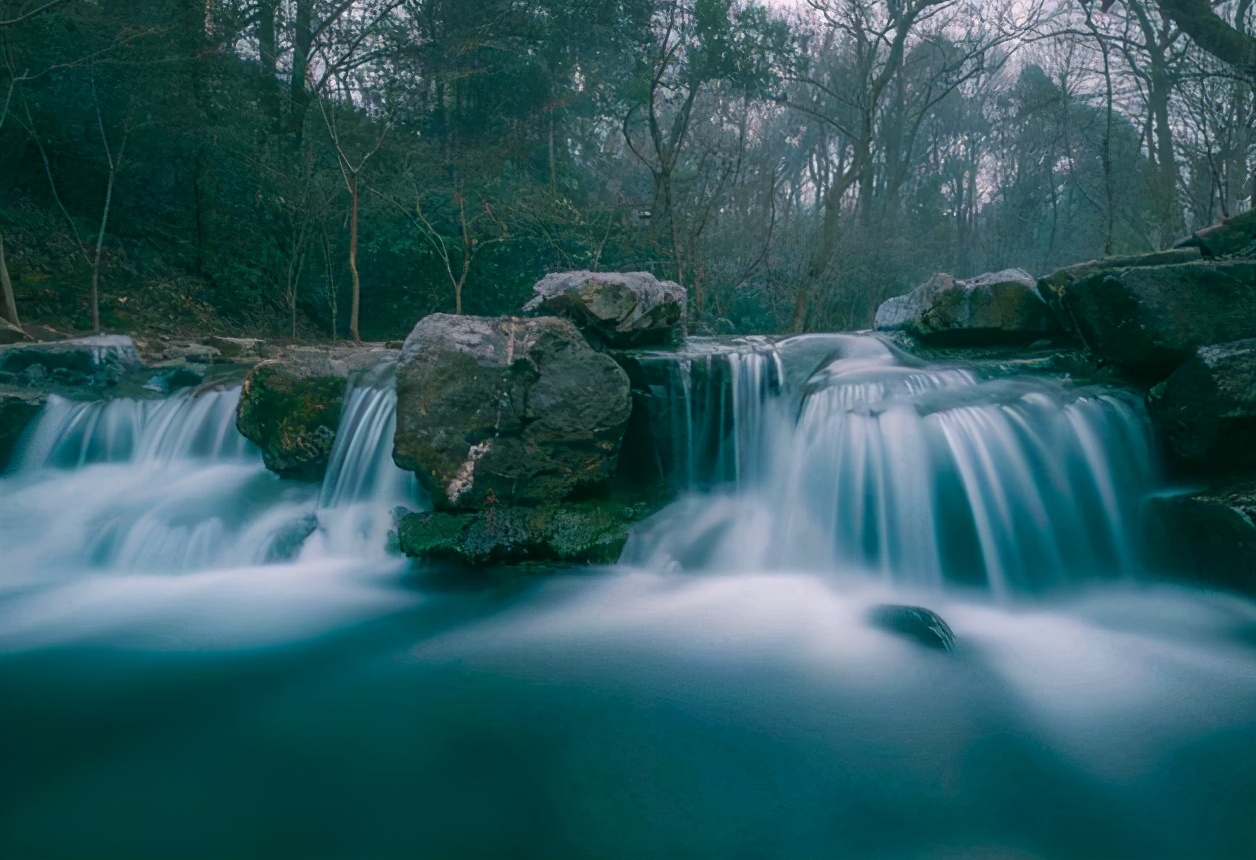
[{"x1": 236, "y1": 352, "x2": 348, "y2": 481}]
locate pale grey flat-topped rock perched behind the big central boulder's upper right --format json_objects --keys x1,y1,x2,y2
[{"x1": 524, "y1": 271, "x2": 685, "y2": 348}]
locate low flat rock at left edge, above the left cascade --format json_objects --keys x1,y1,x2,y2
[{"x1": 0, "y1": 334, "x2": 143, "y2": 387}]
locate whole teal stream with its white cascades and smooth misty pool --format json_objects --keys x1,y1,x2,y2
[{"x1": 0, "y1": 335, "x2": 1256, "y2": 860}]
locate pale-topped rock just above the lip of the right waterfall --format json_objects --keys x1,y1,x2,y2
[{"x1": 875, "y1": 269, "x2": 1060, "y2": 345}]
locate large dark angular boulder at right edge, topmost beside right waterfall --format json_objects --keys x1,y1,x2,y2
[{"x1": 1063, "y1": 261, "x2": 1256, "y2": 379}]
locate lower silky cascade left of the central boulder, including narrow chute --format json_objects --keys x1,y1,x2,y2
[{"x1": 0, "y1": 372, "x2": 421, "y2": 575}]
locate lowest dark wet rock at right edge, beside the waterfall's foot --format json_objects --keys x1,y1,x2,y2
[{"x1": 1145, "y1": 475, "x2": 1256, "y2": 594}]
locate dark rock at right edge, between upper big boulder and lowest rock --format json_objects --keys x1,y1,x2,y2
[{"x1": 1147, "y1": 339, "x2": 1256, "y2": 468}]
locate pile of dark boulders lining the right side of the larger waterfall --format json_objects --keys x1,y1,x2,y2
[{"x1": 877, "y1": 210, "x2": 1256, "y2": 591}]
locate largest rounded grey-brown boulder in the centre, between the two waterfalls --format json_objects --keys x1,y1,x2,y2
[{"x1": 393, "y1": 314, "x2": 629, "y2": 510}]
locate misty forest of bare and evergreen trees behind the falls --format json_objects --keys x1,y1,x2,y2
[{"x1": 0, "y1": 0, "x2": 1256, "y2": 339}]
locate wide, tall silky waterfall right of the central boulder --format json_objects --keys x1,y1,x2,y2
[{"x1": 625, "y1": 338, "x2": 1153, "y2": 594}]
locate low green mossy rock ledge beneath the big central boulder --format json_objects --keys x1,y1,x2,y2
[{"x1": 399, "y1": 503, "x2": 638, "y2": 567}]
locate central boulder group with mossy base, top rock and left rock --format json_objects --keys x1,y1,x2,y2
[{"x1": 228, "y1": 271, "x2": 685, "y2": 566}]
